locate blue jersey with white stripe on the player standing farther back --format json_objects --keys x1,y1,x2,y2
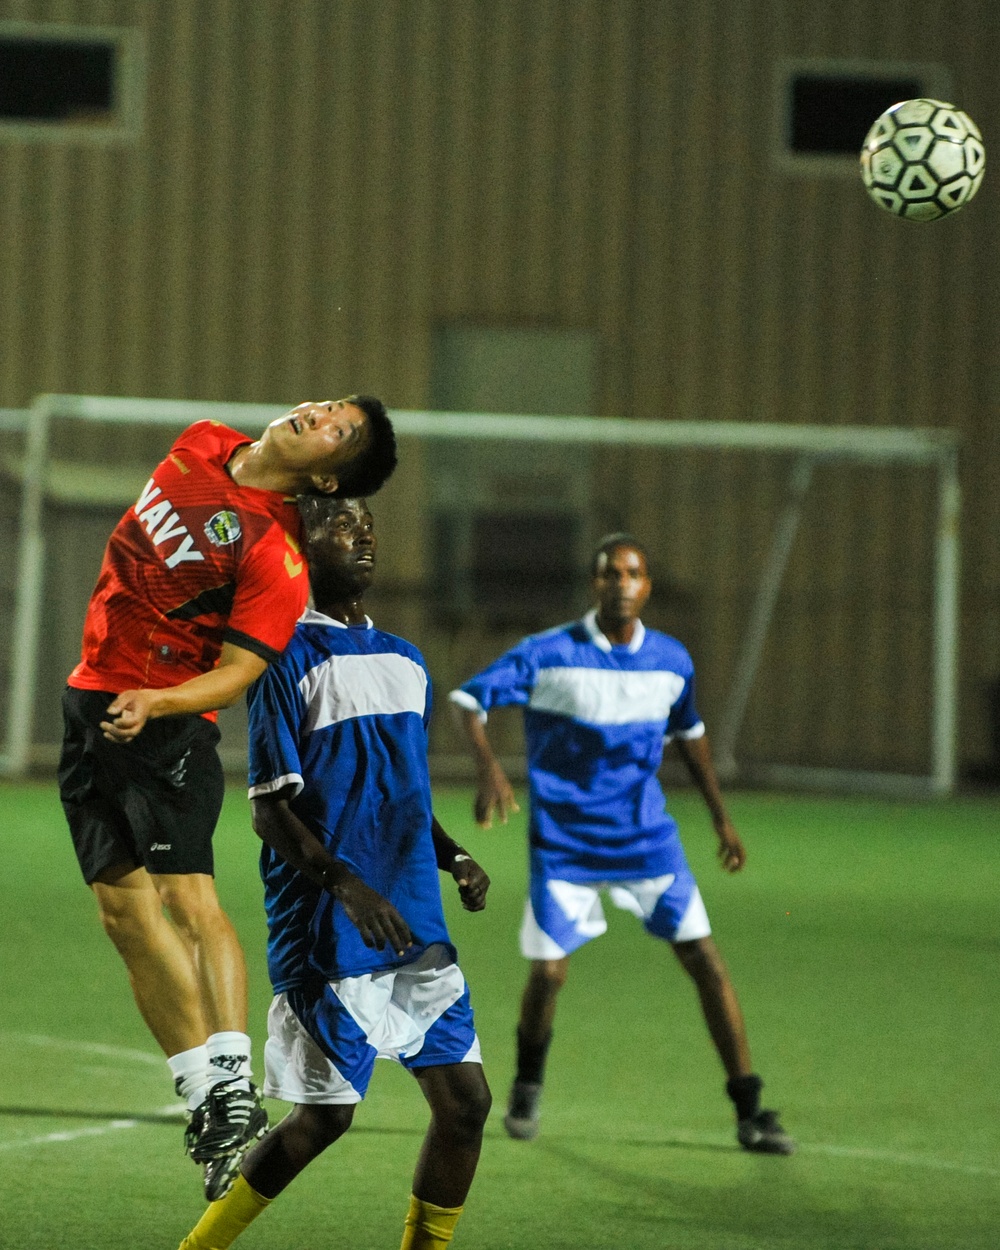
[{"x1": 450, "y1": 611, "x2": 705, "y2": 881}]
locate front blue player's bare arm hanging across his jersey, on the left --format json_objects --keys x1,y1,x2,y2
[{"x1": 250, "y1": 791, "x2": 413, "y2": 955}]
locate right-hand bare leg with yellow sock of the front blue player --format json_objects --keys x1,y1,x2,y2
[{"x1": 401, "y1": 1063, "x2": 493, "y2": 1250}]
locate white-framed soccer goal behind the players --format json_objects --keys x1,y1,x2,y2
[{"x1": 0, "y1": 395, "x2": 960, "y2": 795}]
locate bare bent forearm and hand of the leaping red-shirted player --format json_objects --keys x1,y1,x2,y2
[{"x1": 101, "y1": 643, "x2": 268, "y2": 743}]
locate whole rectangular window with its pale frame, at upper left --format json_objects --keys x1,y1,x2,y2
[{"x1": 0, "y1": 21, "x2": 144, "y2": 143}]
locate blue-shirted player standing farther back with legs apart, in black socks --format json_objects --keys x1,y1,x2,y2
[{"x1": 450, "y1": 534, "x2": 794, "y2": 1154}]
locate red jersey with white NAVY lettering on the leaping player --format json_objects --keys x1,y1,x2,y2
[{"x1": 69, "y1": 421, "x2": 309, "y2": 694}]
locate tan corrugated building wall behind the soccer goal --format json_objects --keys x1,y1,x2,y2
[{"x1": 0, "y1": 0, "x2": 1000, "y2": 769}]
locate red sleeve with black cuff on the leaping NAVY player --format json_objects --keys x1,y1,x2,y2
[{"x1": 223, "y1": 525, "x2": 309, "y2": 664}]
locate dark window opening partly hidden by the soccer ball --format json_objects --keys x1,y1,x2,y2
[{"x1": 790, "y1": 74, "x2": 925, "y2": 156}]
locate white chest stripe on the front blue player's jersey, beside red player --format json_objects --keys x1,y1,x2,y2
[{"x1": 292, "y1": 651, "x2": 428, "y2": 734}]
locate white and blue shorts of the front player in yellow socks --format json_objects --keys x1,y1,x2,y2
[{"x1": 264, "y1": 945, "x2": 483, "y2": 1104}]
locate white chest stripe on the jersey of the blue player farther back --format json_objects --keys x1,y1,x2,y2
[{"x1": 529, "y1": 668, "x2": 684, "y2": 725}]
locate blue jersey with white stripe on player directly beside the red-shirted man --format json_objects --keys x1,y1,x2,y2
[{"x1": 248, "y1": 609, "x2": 454, "y2": 993}]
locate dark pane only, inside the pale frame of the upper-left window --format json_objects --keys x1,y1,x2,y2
[{"x1": 0, "y1": 36, "x2": 118, "y2": 123}]
